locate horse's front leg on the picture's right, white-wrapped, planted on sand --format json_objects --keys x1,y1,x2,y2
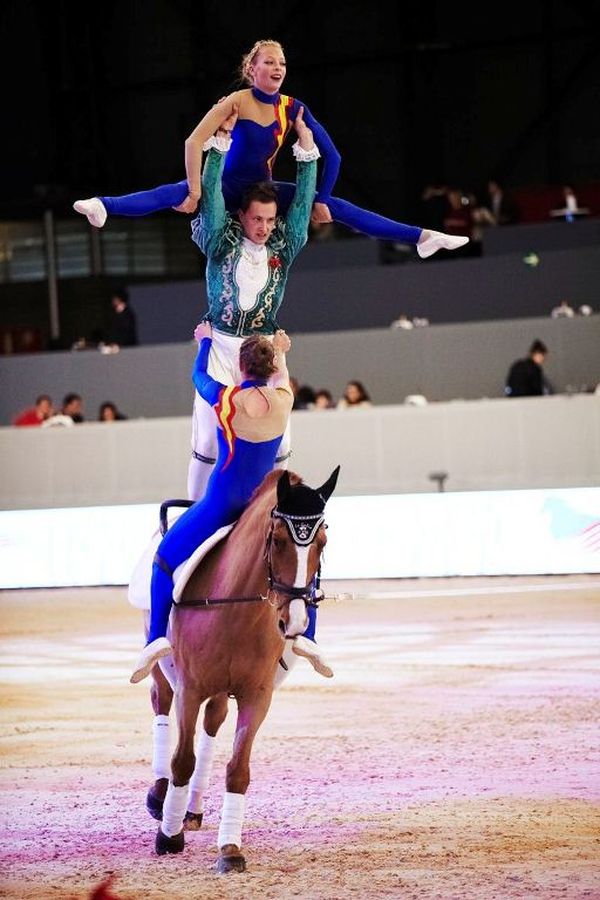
[{"x1": 217, "y1": 685, "x2": 273, "y2": 873}]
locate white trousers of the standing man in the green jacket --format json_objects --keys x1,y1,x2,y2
[{"x1": 187, "y1": 330, "x2": 291, "y2": 500}]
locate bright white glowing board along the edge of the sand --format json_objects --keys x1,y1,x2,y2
[{"x1": 0, "y1": 488, "x2": 600, "y2": 588}]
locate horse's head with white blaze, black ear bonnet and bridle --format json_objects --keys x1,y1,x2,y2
[{"x1": 267, "y1": 466, "x2": 340, "y2": 637}]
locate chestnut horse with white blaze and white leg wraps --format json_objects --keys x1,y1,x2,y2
[{"x1": 141, "y1": 466, "x2": 339, "y2": 873}]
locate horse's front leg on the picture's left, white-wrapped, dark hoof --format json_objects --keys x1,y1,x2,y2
[{"x1": 155, "y1": 685, "x2": 204, "y2": 856}]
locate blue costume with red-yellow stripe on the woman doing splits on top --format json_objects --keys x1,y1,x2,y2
[{"x1": 99, "y1": 87, "x2": 422, "y2": 244}]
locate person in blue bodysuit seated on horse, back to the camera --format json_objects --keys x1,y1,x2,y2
[{"x1": 131, "y1": 323, "x2": 333, "y2": 684}]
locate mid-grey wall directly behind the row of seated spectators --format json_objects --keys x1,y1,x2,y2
[{"x1": 0, "y1": 316, "x2": 600, "y2": 425}]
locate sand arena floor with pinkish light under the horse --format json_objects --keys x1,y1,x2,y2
[{"x1": 0, "y1": 576, "x2": 600, "y2": 900}]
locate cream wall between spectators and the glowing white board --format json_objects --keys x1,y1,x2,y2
[{"x1": 0, "y1": 395, "x2": 600, "y2": 509}]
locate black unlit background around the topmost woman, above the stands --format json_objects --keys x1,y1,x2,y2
[{"x1": 0, "y1": 0, "x2": 600, "y2": 216}]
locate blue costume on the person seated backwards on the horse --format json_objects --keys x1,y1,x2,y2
[{"x1": 147, "y1": 338, "x2": 315, "y2": 644}]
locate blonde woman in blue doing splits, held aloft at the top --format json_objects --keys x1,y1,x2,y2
[{"x1": 73, "y1": 40, "x2": 468, "y2": 258}]
